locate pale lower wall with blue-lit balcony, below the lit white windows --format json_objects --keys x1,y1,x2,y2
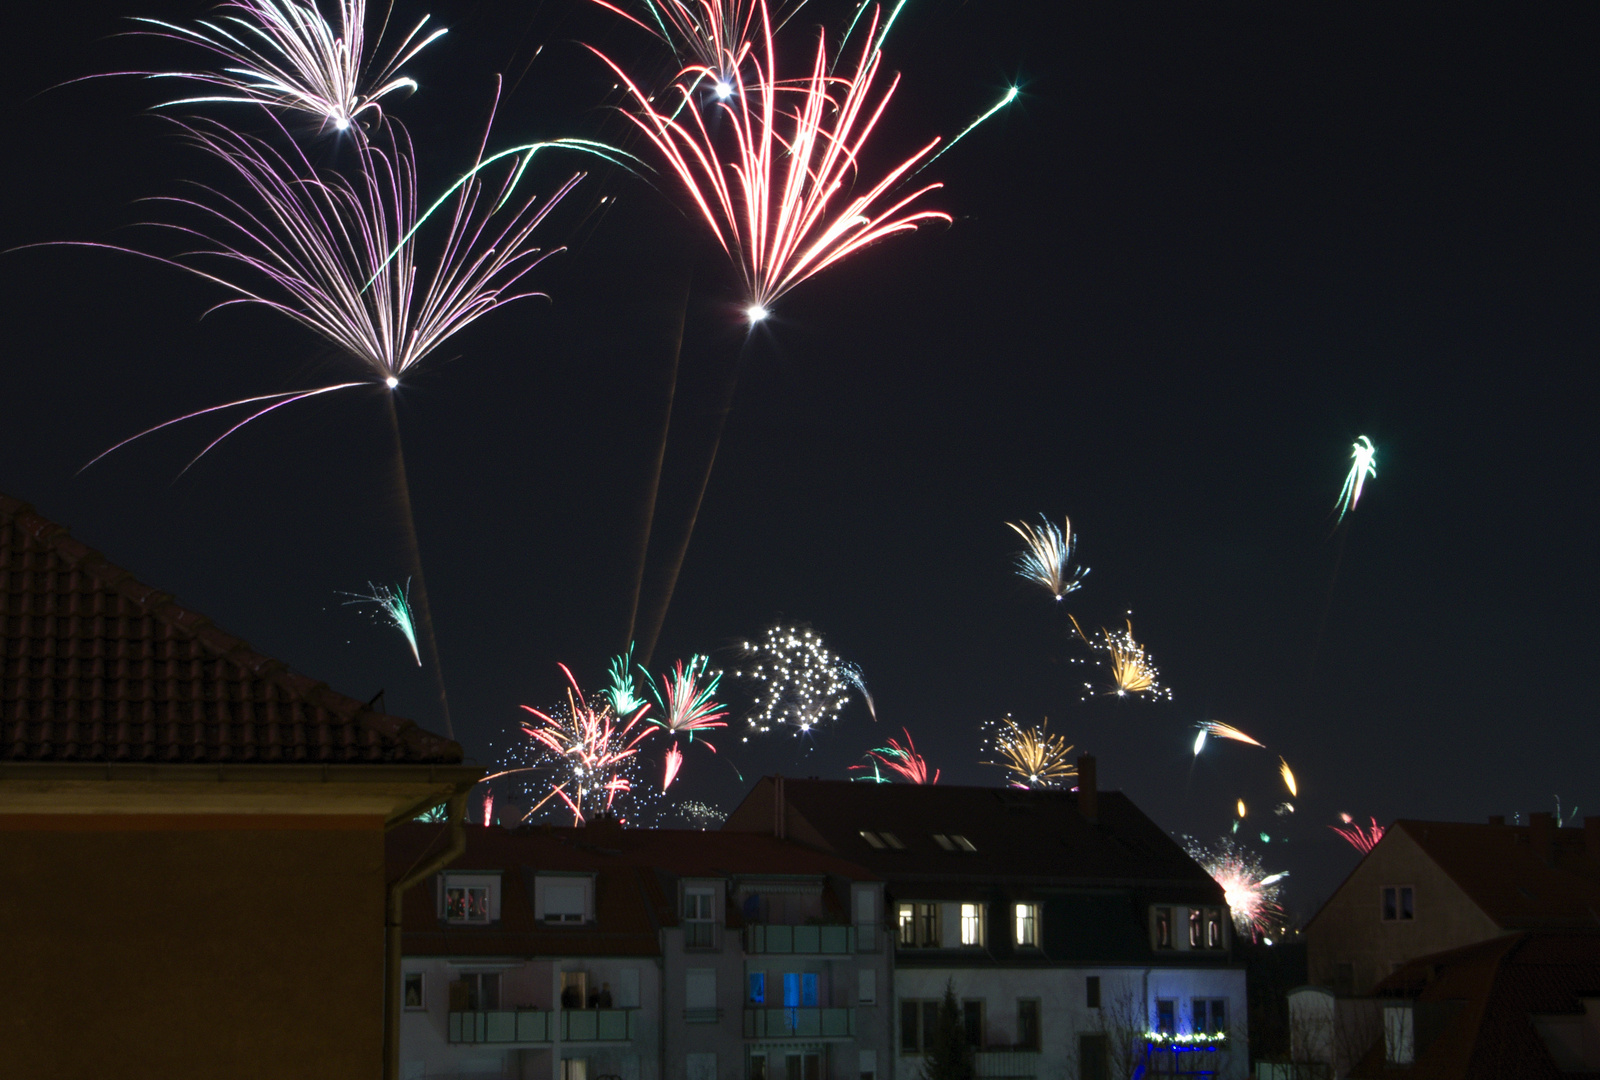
[{"x1": 891, "y1": 966, "x2": 1250, "y2": 1080}]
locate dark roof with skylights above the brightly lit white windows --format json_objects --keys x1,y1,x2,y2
[{"x1": 723, "y1": 776, "x2": 1221, "y2": 902}]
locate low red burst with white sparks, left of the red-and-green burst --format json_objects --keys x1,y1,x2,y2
[{"x1": 522, "y1": 664, "x2": 654, "y2": 826}]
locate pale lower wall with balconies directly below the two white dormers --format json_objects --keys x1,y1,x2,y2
[{"x1": 400, "y1": 957, "x2": 661, "y2": 1080}]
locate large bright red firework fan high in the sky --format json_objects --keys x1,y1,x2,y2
[{"x1": 590, "y1": 0, "x2": 950, "y2": 323}]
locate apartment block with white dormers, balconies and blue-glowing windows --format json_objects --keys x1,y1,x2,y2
[{"x1": 389, "y1": 818, "x2": 891, "y2": 1080}]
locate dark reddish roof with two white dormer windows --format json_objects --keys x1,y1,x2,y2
[{"x1": 387, "y1": 822, "x2": 872, "y2": 957}]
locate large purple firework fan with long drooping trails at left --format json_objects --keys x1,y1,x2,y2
[{"x1": 70, "y1": 100, "x2": 584, "y2": 469}]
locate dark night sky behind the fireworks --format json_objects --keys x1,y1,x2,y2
[{"x1": 0, "y1": 0, "x2": 1600, "y2": 917}]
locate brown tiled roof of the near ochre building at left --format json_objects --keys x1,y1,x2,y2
[{"x1": 0, "y1": 494, "x2": 461, "y2": 765}]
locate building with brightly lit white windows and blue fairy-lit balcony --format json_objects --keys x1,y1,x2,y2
[{"x1": 723, "y1": 757, "x2": 1250, "y2": 1080}]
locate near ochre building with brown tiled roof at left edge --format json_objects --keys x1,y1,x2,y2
[{"x1": 0, "y1": 496, "x2": 482, "y2": 1080}]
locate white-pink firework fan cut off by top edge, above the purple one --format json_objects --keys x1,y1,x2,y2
[{"x1": 126, "y1": 0, "x2": 445, "y2": 131}]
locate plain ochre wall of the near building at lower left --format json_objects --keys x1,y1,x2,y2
[{"x1": 0, "y1": 814, "x2": 384, "y2": 1080}]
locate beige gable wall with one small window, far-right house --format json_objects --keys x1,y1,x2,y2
[{"x1": 1306, "y1": 829, "x2": 1504, "y2": 995}]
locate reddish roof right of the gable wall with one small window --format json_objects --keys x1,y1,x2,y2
[{"x1": 1394, "y1": 821, "x2": 1600, "y2": 930}]
